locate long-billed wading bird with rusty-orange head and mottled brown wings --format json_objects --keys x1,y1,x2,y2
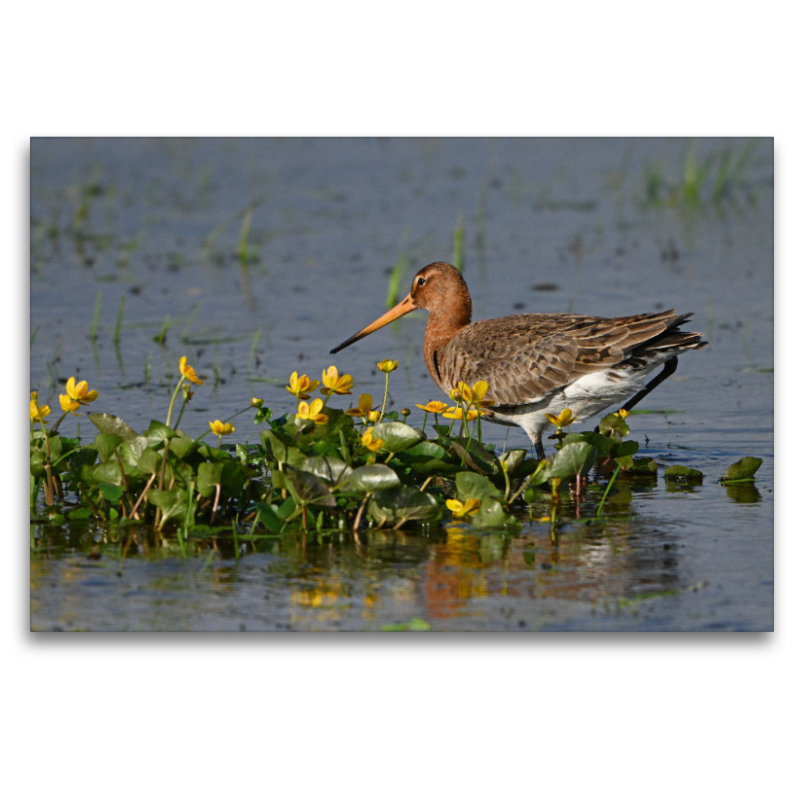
[{"x1": 331, "y1": 261, "x2": 708, "y2": 458}]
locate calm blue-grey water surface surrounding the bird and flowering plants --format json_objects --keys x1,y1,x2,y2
[{"x1": 31, "y1": 139, "x2": 774, "y2": 631}]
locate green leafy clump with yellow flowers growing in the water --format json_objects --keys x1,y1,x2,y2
[{"x1": 30, "y1": 356, "x2": 761, "y2": 548}]
